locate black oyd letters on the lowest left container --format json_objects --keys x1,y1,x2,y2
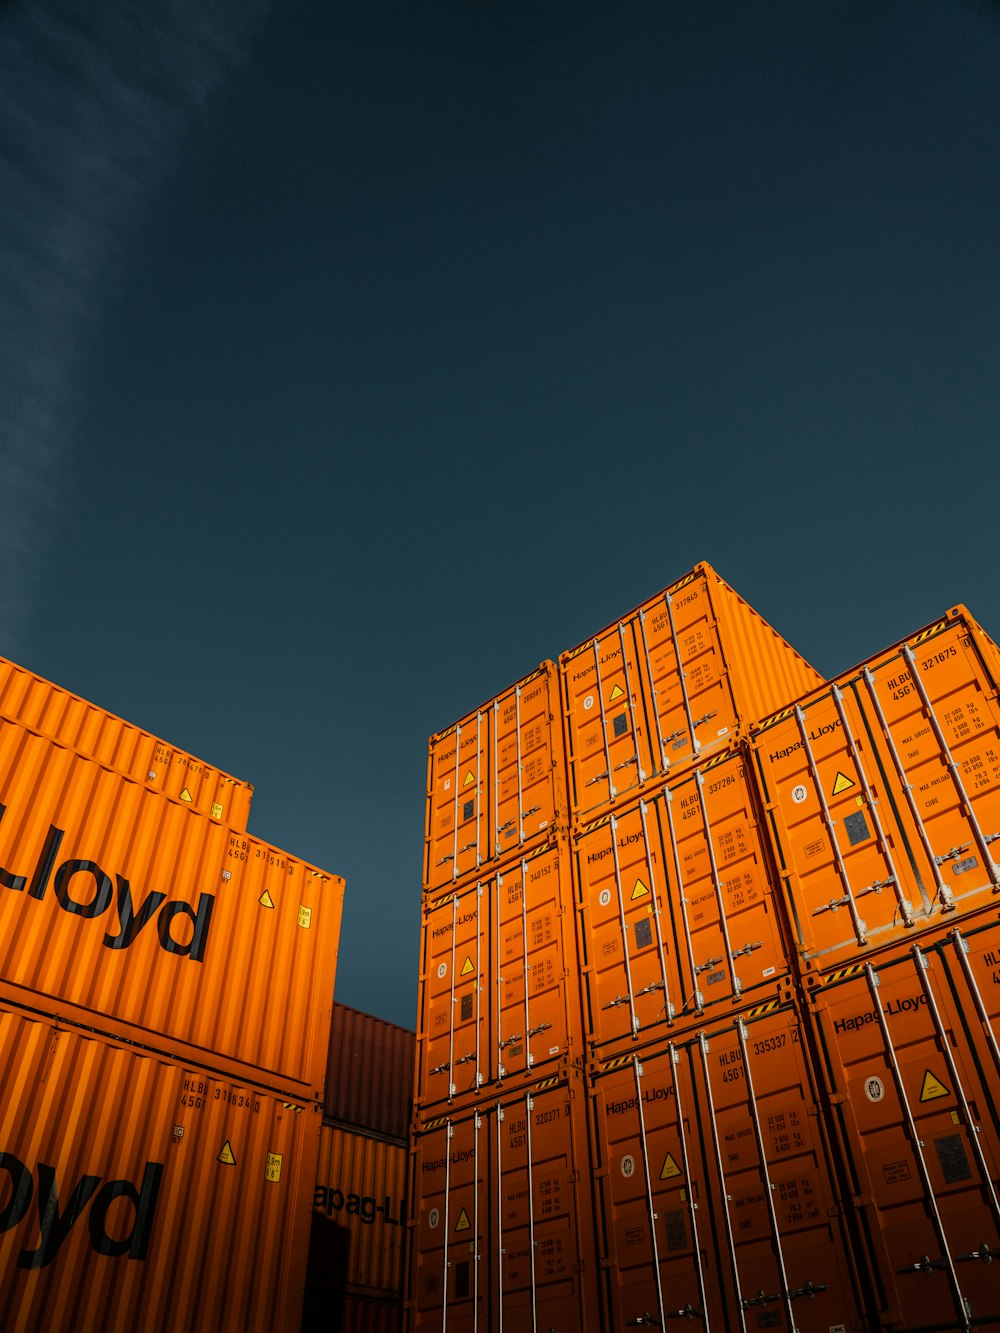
[{"x1": 0, "y1": 1152, "x2": 163, "y2": 1269}]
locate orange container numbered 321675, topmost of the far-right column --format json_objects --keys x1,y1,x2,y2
[{"x1": 753, "y1": 607, "x2": 1000, "y2": 969}]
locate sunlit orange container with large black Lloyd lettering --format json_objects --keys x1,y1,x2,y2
[{"x1": 0, "y1": 722, "x2": 344, "y2": 1097}]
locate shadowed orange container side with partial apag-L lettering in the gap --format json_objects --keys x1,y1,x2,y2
[{"x1": 312, "y1": 1125, "x2": 407, "y2": 1300}]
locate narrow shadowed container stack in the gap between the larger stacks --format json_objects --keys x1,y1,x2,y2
[{"x1": 301, "y1": 1004, "x2": 413, "y2": 1333}]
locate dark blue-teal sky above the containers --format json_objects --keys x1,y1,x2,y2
[{"x1": 0, "y1": 0, "x2": 1000, "y2": 1025}]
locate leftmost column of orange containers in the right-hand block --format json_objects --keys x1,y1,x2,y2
[{"x1": 408, "y1": 663, "x2": 596, "y2": 1330}]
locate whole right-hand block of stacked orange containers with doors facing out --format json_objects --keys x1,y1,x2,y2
[{"x1": 408, "y1": 565, "x2": 1000, "y2": 1333}]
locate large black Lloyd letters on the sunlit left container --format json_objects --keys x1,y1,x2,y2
[{"x1": 0, "y1": 805, "x2": 215, "y2": 962}]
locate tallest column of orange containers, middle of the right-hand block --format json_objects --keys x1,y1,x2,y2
[{"x1": 560, "y1": 565, "x2": 874, "y2": 1333}]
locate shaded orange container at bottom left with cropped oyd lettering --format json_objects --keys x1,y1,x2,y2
[{"x1": 0, "y1": 1006, "x2": 320, "y2": 1333}]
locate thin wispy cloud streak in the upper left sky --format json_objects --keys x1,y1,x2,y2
[{"x1": 0, "y1": 0, "x2": 267, "y2": 657}]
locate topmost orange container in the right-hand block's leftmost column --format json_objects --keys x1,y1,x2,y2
[{"x1": 424, "y1": 663, "x2": 565, "y2": 892}]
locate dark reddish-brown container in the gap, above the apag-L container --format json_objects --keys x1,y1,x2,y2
[{"x1": 323, "y1": 1004, "x2": 416, "y2": 1142}]
